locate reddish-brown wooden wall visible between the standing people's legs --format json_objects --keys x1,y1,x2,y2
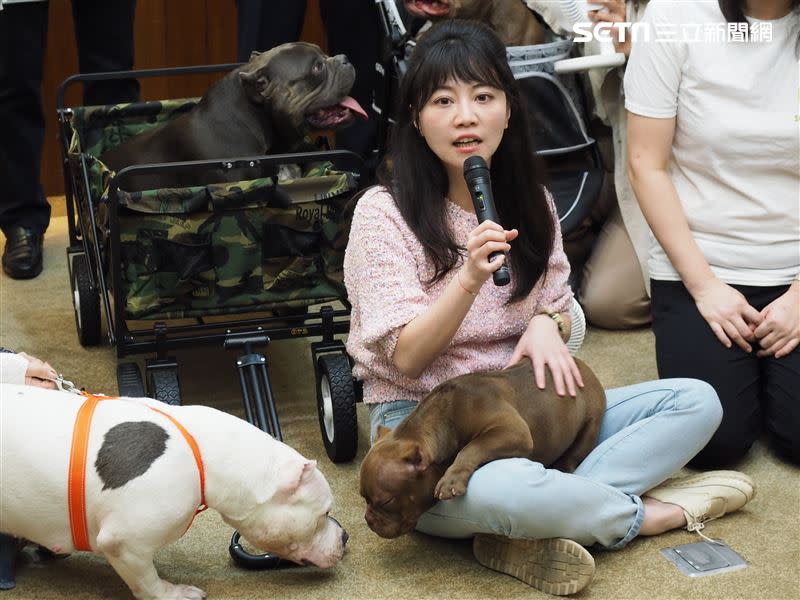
[{"x1": 42, "y1": 0, "x2": 326, "y2": 196}]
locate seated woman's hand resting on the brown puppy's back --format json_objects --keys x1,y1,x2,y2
[{"x1": 506, "y1": 315, "x2": 583, "y2": 396}]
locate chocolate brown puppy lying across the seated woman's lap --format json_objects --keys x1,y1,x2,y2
[{"x1": 361, "y1": 359, "x2": 606, "y2": 538}]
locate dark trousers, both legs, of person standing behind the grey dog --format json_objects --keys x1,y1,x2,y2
[{"x1": 237, "y1": 0, "x2": 380, "y2": 158}]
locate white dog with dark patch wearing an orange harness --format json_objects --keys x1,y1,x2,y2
[{"x1": 0, "y1": 383, "x2": 347, "y2": 600}]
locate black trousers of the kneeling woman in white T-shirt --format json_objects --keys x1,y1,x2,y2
[{"x1": 651, "y1": 280, "x2": 800, "y2": 469}]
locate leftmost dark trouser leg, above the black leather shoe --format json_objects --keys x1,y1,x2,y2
[{"x1": 0, "y1": 2, "x2": 50, "y2": 232}]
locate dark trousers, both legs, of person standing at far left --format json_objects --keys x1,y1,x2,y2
[{"x1": 0, "y1": 0, "x2": 139, "y2": 232}]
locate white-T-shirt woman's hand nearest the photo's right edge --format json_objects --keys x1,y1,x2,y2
[{"x1": 753, "y1": 281, "x2": 800, "y2": 358}]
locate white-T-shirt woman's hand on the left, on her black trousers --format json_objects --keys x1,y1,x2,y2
[{"x1": 692, "y1": 277, "x2": 763, "y2": 352}]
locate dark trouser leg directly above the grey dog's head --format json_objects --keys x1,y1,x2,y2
[{"x1": 236, "y1": 0, "x2": 306, "y2": 62}]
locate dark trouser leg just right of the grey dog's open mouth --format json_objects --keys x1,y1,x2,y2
[{"x1": 320, "y1": 0, "x2": 380, "y2": 157}]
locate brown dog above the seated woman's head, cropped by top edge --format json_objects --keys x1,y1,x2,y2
[{"x1": 404, "y1": 0, "x2": 545, "y2": 46}]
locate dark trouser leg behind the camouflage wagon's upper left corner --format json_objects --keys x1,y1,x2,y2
[{"x1": 72, "y1": 0, "x2": 139, "y2": 106}]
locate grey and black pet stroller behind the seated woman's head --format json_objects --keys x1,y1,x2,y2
[{"x1": 373, "y1": 0, "x2": 604, "y2": 237}]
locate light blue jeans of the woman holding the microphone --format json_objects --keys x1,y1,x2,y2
[{"x1": 369, "y1": 379, "x2": 722, "y2": 550}]
